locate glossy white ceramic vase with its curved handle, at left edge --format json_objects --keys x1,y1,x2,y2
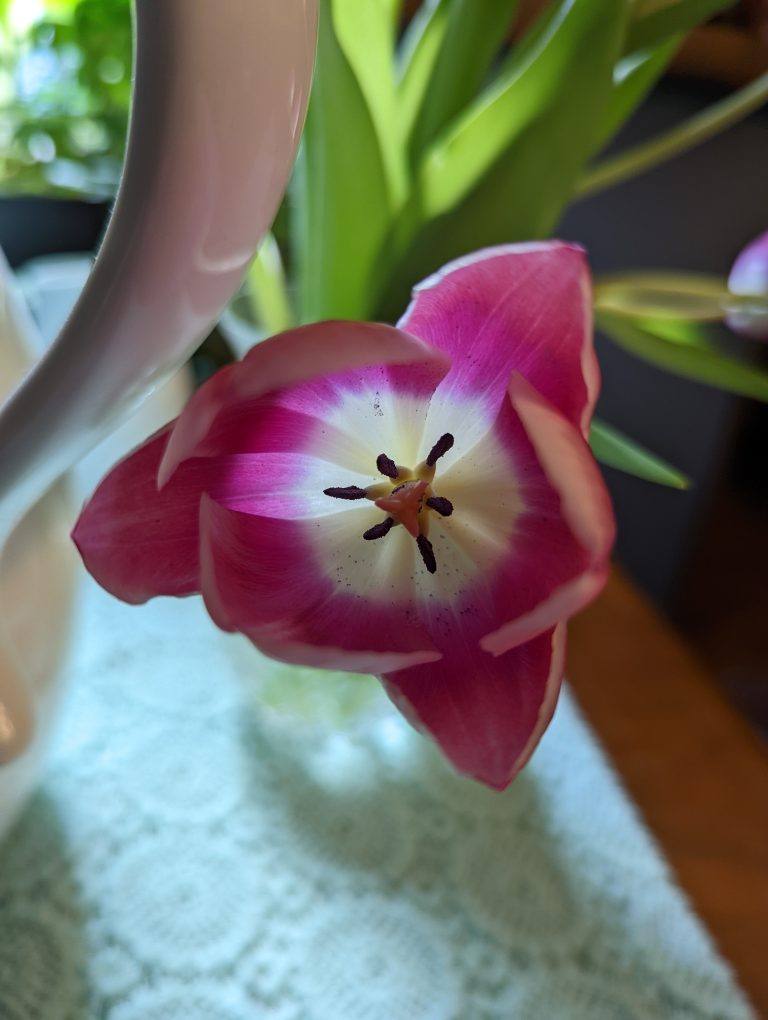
[{"x1": 0, "y1": 0, "x2": 317, "y2": 832}]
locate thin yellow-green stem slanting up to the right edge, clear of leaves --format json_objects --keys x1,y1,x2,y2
[{"x1": 575, "y1": 72, "x2": 768, "y2": 198}]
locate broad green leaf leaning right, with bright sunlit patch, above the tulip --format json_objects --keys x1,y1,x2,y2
[{"x1": 376, "y1": 0, "x2": 626, "y2": 318}]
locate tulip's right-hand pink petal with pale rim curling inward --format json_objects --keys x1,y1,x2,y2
[{"x1": 480, "y1": 373, "x2": 615, "y2": 655}]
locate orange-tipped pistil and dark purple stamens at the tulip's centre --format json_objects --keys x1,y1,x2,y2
[{"x1": 323, "y1": 432, "x2": 454, "y2": 573}]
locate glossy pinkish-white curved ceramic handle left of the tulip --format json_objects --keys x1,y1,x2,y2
[{"x1": 0, "y1": 0, "x2": 316, "y2": 545}]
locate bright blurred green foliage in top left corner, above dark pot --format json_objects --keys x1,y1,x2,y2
[{"x1": 0, "y1": 0, "x2": 133, "y2": 197}]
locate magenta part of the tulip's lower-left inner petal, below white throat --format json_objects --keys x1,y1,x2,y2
[{"x1": 194, "y1": 497, "x2": 440, "y2": 673}]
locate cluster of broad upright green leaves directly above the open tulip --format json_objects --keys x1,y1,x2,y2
[{"x1": 289, "y1": 0, "x2": 732, "y2": 321}]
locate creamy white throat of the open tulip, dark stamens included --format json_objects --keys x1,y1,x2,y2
[{"x1": 300, "y1": 383, "x2": 525, "y2": 606}]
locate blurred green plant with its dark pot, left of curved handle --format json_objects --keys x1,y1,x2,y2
[{"x1": 0, "y1": 0, "x2": 133, "y2": 265}]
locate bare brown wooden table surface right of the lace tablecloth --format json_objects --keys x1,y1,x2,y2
[{"x1": 568, "y1": 571, "x2": 768, "y2": 1017}]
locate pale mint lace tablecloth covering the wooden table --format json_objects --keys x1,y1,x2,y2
[{"x1": 0, "y1": 583, "x2": 752, "y2": 1020}]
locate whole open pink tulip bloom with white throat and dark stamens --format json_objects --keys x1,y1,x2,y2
[{"x1": 74, "y1": 242, "x2": 614, "y2": 788}]
